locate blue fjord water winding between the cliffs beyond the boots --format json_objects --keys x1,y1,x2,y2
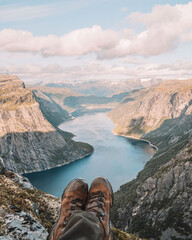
[{"x1": 25, "y1": 113, "x2": 155, "y2": 197}]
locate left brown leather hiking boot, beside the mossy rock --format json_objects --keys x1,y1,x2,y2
[{"x1": 48, "y1": 179, "x2": 88, "y2": 240}]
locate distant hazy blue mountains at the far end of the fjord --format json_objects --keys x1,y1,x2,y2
[{"x1": 30, "y1": 86, "x2": 135, "y2": 118}]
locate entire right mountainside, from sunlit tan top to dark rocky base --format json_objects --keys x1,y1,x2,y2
[{"x1": 109, "y1": 80, "x2": 192, "y2": 239}]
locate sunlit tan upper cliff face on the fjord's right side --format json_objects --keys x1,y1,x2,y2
[{"x1": 109, "y1": 80, "x2": 192, "y2": 138}]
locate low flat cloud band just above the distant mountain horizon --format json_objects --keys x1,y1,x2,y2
[{"x1": 0, "y1": 61, "x2": 192, "y2": 82}]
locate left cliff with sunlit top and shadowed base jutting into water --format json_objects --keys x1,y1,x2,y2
[{"x1": 0, "y1": 75, "x2": 93, "y2": 173}]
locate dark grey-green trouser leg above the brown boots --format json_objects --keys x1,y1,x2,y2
[{"x1": 59, "y1": 210, "x2": 104, "y2": 240}]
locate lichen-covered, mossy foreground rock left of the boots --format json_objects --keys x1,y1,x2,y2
[{"x1": 0, "y1": 172, "x2": 61, "y2": 240}]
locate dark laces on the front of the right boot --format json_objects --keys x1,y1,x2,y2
[{"x1": 86, "y1": 191, "x2": 105, "y2": 222}]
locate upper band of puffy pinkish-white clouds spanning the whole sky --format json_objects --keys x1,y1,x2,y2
[{"x1": 0, "y1": 2, "x2": 192, "y2": 59}]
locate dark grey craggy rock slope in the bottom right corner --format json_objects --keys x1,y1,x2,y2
[{"x1": 115, "y1": 140, "x2": 192, "y2": 240}]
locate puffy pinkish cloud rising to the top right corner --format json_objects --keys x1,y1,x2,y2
[{"x1": 101, "y1": 2, "x2": 192, "y2": 58}]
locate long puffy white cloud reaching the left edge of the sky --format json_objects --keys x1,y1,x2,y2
[{"x1": 0, "y1": 26, "x2": 118, "y2": 56}]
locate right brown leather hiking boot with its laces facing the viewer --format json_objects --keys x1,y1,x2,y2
[{"x1": 85, "y1": 177, "x2": 113, "y2": 240}]
